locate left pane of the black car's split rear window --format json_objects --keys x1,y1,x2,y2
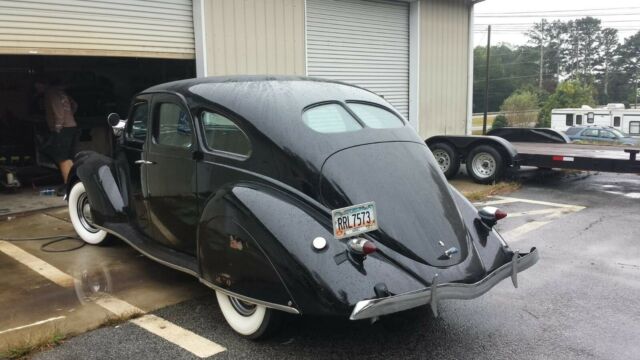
[{"x1": 302, "y1": 104, "x2": 362, "y2": 133}]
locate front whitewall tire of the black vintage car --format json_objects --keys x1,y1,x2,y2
[{"x1": 68, "y1": 182, "x2": 108, "y2": 245}]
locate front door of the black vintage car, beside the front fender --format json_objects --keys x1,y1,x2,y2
[{"x1": 117, "y1": 95, "x2": 151, "y2": 236}]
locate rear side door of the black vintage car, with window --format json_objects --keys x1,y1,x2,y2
[{"x1": 144, "y1": 94, "x2": 198, "y2": 255}]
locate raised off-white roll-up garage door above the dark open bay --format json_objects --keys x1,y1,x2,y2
[{"x1": 0, "y1": 0, "x2": 195, "y2": 59}]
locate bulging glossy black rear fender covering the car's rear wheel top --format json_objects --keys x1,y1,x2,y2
[{"x1": 199, "y1": 184, "x2": 424, "y2": 316}]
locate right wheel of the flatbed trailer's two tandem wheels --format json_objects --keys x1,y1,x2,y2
[{"x1": 467, "y1": 145, "x2": 504, "y2": 184}]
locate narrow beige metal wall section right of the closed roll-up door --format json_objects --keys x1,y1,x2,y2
[{"x1": 419, "y1": 0, "x2": 470, "y2": 138}]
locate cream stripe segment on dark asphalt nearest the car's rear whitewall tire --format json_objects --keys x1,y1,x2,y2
[{"x1": 131, "y1": 314, "x2": 227, "y2": 358}]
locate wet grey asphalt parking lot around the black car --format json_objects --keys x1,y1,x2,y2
[{"x1": 0, "y1": 173, "x2": 640, "y2": 360}]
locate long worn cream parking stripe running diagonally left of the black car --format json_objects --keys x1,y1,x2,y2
[{"x1": 0, "y1": 240, "x2": 226, "y2": 357}]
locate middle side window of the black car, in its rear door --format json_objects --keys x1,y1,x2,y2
[{"x1": 154, "y1": 102, "x2": 193, "y2": 149}]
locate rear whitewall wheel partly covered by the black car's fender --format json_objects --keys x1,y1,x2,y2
[{"x1": 216, "y1": 291, "x2": 282, "y2": 339}]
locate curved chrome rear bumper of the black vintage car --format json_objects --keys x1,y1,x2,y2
[{"x1": 350, "y1": 248, "x2": 538, "y2": 320}]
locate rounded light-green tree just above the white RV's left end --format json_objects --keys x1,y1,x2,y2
[{"x1": 536, "y1": 80, "x2": 596, "y2": 127}]
